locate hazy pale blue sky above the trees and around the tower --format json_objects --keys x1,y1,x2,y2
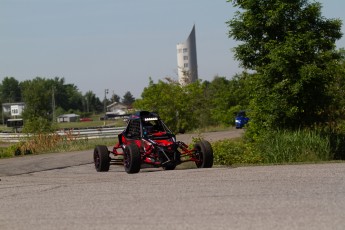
[{"x1": 0, "y1": 0, "x2": 345, "y2": 99}]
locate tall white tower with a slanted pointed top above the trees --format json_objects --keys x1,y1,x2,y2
[{"x1": 176, "y1": 25, "x2": 198, "y2": 85}]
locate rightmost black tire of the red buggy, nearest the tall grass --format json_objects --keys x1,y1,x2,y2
[{"x1": 194, "y1": 140, "x2": 213, "y2": 168}]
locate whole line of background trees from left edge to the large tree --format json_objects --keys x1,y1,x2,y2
[{"x1": 0, "y1": 73, "x2": 250, "y2": 131}]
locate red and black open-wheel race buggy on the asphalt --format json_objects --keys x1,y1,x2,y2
[{"x1": 93, "y1": 111, "x2": 213, "y2": 173}]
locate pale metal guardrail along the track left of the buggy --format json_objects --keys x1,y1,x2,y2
[{"x1": 0, "y1": 127, "x2": 125, "y2": 142}]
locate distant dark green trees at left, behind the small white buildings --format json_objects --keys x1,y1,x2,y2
[{"x1": 0, "y1": 77, "x2": 135, "y2": 128}]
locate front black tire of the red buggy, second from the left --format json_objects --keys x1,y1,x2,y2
[{"x1": 123, "y1": 144, "x2": 141, "y2": 174}]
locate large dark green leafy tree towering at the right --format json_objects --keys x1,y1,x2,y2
[{"x1": 227, "y1": 0, "x2": 342, "y2": 130}]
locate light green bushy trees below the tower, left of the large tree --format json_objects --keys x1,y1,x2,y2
[{"x1": 133, "y1": 73, "x2": 251, "y2": 132}]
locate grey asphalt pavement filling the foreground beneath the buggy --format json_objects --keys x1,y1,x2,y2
[{"x1": 0, "y1": 130, "x2": 345, "y2": 230}]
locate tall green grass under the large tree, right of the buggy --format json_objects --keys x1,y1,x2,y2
[{"x1": 212, "y1": 130, "x2": 332, "y2": 165}]
